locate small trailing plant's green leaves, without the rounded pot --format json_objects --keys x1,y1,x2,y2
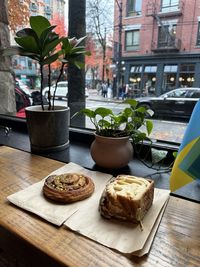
[{"x1": 75, "y1": 99, "x2": 153, "y2": 144}]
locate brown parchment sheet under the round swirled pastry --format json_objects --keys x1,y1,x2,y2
[{"x1": 7, "y1": 163, "x2": 112, "y2": 226}]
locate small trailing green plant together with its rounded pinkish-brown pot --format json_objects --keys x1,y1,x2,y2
[{"x1": 76, "y1": 99, "x2": 153, "y2": 169}]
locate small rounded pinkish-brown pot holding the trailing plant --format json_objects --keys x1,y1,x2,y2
[{"x1": 90, "y1": 134, "x2": 133, "y2": 169}]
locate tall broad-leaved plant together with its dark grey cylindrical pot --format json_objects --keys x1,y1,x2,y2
[{"x1": 3, "y1": 16, "x2": 89, "y2": 152}]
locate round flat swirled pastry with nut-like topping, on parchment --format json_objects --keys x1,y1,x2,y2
[{"x1": 43, "y1": 173, "x2": 95, "y2": 203}]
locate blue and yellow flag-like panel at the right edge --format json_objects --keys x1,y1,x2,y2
[{"x1": 170, "y1": 100, "x2": 200, "y2": 191}]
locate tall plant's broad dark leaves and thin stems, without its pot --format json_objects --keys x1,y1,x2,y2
[{"x1": 3, "y1": 16, "x2": 90, "y2": 110}]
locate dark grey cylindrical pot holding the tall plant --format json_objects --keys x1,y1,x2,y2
[{"x1": 25, "y1": 106, "x2": 70, "y2": 153}]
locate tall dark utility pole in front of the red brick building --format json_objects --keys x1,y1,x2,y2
[{"x1": 115, "y1": 0, "x2": 122, "y2": 98}]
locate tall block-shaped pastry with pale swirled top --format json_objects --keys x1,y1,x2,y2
[{"x1": 99, "y1": 175, "x2": 154, "y2": 223}]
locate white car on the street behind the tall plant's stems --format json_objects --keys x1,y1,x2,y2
[{"x1": 43, "y1": 81, "x2": 89, "y2": 99}]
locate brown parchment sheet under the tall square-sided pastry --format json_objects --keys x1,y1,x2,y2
[{"x1": 64, "y1": 188, "x2": 170, "y2": 256}]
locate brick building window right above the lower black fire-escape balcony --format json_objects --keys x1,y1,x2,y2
[{"x1": 158, "y1": 25, "x2": 176, "y2": 48}]
